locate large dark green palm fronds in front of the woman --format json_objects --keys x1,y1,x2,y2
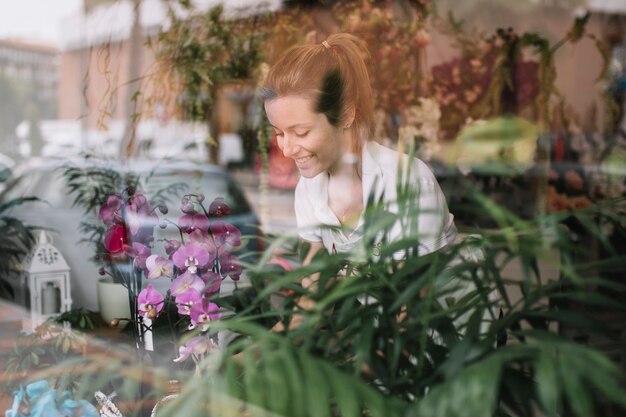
[{"x1": 164, "y1": 180, "x2": 626, "y2": 416}]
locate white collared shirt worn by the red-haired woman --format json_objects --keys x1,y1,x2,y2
[{"x1": 294, "y1": 142, "x2": 456, "y2": 259}]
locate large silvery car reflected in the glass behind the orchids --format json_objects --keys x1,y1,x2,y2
[{"x1": 0, "y1": 160, "x2": 261, "y2": 311}]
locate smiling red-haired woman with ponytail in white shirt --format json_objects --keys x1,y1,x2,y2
[{"x1": 261, "y1": 34, "x2": 456, "y2": 262}]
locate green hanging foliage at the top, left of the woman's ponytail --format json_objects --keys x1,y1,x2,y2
[{"x1": 155, "y1": 1, "x2": 264, "y2": 121}]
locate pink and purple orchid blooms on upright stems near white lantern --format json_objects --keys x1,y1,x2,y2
[{"x1": 99, "y1": 189, "x2": 242, "y2": 361}]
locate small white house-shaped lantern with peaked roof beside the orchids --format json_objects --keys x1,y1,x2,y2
[{"x1": 22, "y1": 230, "x2": 72, "y2": 332}]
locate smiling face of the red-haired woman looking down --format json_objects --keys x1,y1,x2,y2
[{"x1": 265, "y1": 95, "x2": 348, "y2": 178}]
